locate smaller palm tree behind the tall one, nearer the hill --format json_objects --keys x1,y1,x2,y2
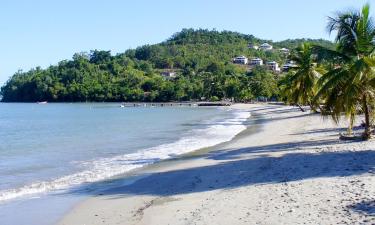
[{"x1": 281, "y1": 43, "x2": 321, "y2": 111}]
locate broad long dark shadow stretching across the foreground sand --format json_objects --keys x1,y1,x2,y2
[{"x1": 97, "y1": 150, "x2": 375, "y2": 198}]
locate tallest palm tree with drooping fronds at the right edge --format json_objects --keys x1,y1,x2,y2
[{"x1": 314, "y1": 4, "x2": 375, "y2": 140}]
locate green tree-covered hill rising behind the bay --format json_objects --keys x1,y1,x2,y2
[{"x1": 0, "y1": 29, "x2": 333, "y2": 102}]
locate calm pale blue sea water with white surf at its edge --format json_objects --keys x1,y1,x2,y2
[{"x1": 0, "y1": 103, "x2": 253, "y2": 224}]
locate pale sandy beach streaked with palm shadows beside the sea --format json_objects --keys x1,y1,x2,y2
[{"x1": 58, "y1": 104, "x2": 375, "y2": 225}]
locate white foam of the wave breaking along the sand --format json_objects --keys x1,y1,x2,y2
[{"x1": 0, "y1": 111, "x2": 250, "y2": 202}]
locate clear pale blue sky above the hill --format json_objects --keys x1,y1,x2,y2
[{"x1": 0, "y1": 0, "x2": 375, "y2": 85}]
